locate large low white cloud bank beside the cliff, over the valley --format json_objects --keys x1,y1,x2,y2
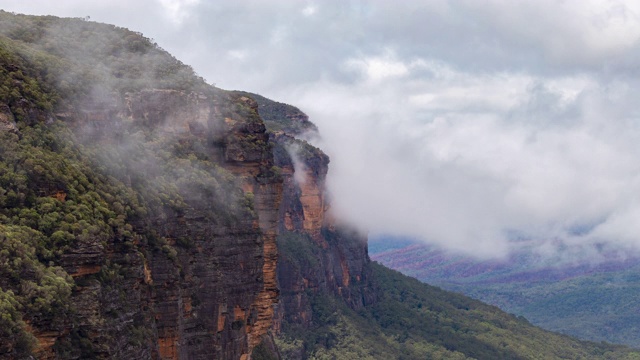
[{"x1": 282, "y1": 60, "x2": 640, "y2": 257}]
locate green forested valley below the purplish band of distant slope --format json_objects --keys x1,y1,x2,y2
[{"x1": 455, "y1": 266, "x2": 640, "y2": 347}]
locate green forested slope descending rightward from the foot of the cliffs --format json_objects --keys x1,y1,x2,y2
[{"x1": 278, "y1": 263, "x2": 640, "y2": 359}]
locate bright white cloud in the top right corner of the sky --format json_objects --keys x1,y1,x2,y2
[{"x1": 462, "y1": 0, "x2": 640, "y2": 64}]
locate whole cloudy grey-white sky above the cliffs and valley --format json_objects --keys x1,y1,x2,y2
[{"x1": 0, "y1": 0, "x2": 640, "y2": 258}]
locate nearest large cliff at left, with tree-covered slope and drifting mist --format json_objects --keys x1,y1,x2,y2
[{"x1": 0, "y1": 13, "x2": 282, "y2": 359}]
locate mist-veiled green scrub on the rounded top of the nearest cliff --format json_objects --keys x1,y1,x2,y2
[{"x1": 0, "y1": 11, "x2": 209, "y2": 100}]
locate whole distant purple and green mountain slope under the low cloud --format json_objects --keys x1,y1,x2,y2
[{"x1": 370, "y1": 240, "x2": 640, "y2": 347}]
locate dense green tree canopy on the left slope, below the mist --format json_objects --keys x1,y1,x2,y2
[{"x1": 0, "y1": 124, "x2": 141, "y2": 357}]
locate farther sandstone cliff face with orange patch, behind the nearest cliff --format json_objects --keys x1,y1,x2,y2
[{"x1": 272, "y1": 126, "x2": 376, "y2": 338}]
